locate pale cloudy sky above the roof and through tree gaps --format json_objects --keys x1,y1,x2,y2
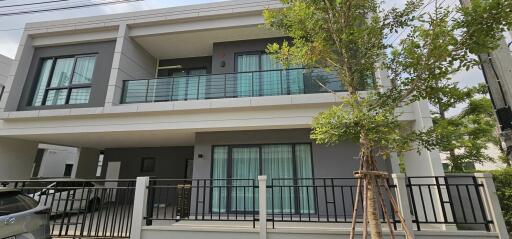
[{"x1": 0, "y1": 0, "x2": 510, "y2": 114}]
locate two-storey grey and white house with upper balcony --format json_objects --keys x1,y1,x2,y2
[{"x1": 0, "y1": 0, "x2": 506, "y2": 238}]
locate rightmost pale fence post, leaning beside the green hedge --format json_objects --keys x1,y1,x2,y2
[{"x1": 474, "y1": 173, "x2": 509, "y2": 239}]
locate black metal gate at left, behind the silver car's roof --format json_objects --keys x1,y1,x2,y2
[{"x1": 0, "y1": 179, "x2": 135, "y2": 238}]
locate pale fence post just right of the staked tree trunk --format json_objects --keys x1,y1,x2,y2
[{"x1": 391, "y1": 173, "x2": 414, "y2": 236}]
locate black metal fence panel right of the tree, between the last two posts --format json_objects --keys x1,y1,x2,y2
[{"x1": 407, "y1": 176, "x2": 492, "y2": 231}]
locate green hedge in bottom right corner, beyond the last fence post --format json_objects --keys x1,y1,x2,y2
[{"x1": 489, "y1": 168, "x2": 512, "y2": 232}]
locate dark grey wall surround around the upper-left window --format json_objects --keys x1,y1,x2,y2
[{"x1": 13, "y1": 41, "x2": 116, "y2": 111}]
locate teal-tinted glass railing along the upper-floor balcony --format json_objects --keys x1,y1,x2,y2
[{"x1": 121, "y1": 68, "x2": 344, "y2": 103}]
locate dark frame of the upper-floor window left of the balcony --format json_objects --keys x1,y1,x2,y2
[{"x1": 27, "y1": 53, "x2": 98, "y2": 107}]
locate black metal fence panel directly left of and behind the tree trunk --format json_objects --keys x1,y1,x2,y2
[{"x1": 267, "y1": 178, "x2": 400, "y2": 230}]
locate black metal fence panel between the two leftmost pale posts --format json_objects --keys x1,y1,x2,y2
[{"x1": 145, "y1": 179, "x2": 258, "y2": 227}]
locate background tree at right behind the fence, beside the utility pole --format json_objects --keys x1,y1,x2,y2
[{"x1": 432, "y1": 84, "x2": 501, "y2": 172}]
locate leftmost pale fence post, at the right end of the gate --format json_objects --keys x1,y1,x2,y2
[{"x1": 130, "y1": 177, "x2": 149, "y2": 239}]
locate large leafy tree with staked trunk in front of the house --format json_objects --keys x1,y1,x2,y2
[{"x1": 264, "y1": 0, "x2": 512, "y2": 238}]
